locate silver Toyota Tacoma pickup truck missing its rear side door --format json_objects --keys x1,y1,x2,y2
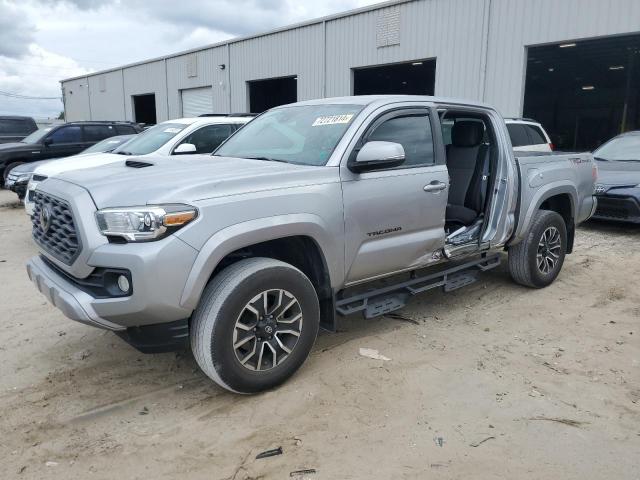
[{"x1": 27, "y1": 96, "x2": 597, "y2": 393}]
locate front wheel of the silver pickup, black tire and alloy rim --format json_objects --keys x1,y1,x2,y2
[{"x1": 190, "y1": 258, "x2": 320, "y2": 394}]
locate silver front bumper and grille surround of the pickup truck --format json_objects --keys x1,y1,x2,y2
[{"x1": 27, "y1": 179, "x2": 198, "y2": 330}]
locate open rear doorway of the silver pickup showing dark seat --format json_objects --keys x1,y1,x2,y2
[{"x1": 442, "y1": 112, "x2": 493, "y2": 244}]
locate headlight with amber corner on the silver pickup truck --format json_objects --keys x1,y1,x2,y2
[{"x1": 96, "y1": 205, "x2": 198, "y2": 242}]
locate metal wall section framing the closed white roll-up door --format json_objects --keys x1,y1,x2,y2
[{"x1": 167, "y1": 46, "x2": 230, "y2": 118}]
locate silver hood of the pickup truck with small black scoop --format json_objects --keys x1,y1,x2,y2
[{"x1": 52, "y1": 155, "x2": 339, "y2": 208}]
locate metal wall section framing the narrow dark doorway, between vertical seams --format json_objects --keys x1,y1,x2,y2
[{"x1": 122, "y1": 60, "x2": 169, "y2": 122}]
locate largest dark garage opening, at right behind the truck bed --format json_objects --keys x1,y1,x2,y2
[{"x1": 523, "y1": 35, "x2": 640, "y2": 150}]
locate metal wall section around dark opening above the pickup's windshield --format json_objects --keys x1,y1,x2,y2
[{"x1": 230, "y1": 24, "x2": 323, "y2": 112}]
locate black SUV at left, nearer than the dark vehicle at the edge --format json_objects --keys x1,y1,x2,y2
[{"x1": 0, "y1": 121, "x2": 142, "y2": 184}]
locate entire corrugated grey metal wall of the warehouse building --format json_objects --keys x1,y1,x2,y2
[{"x1": 63, "y1": 0, "x2": 640, "y2": 121}]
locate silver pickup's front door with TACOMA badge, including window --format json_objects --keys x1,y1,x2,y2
[{"x1": 341, "y1": 108, "x2": 449, "y2": 283}]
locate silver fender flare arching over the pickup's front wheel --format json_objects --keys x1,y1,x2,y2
[{"x1": 180, "y1": 214, "x2": 344, "y2": 309}]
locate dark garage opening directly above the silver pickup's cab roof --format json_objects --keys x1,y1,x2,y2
[{"x1": 353, "y1": 60, "x2": 436, "y2": 95}]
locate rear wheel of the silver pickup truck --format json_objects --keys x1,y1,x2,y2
[{"x1": 509, "y1": 210, "x2": 567, "y2": 288}]
